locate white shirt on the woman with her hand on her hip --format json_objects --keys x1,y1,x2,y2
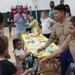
[{"x1": 41, "y1": 17, "x2": 54, "y2": 34}]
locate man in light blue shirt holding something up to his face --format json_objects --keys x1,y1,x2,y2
[{"x1": 14, "y1": 6, "x2": 26, "y2": 38}]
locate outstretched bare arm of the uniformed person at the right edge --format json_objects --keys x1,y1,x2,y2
[{"x1": 40, "y1": 37, "x2": 70, "y2": 65}]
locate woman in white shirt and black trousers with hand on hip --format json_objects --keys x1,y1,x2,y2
[{"x1": 41, "y1": 11, "x2": 56, "y2": 38}]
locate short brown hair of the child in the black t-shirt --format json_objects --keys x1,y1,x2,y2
[{"x1": 0, "y1": 35, "x2": 8, "y2": 55}]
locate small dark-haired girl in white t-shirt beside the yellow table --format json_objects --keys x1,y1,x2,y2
[{"x1": 13, "y1": 38, "x2": 30, "y2": 73}]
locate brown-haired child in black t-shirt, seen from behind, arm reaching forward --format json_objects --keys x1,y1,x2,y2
[{"x1": 0, "y1": 35, "x2": 33, "y2": 75}]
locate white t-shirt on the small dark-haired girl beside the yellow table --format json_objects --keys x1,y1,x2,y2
[{"x1": 14, "y1": 49, "x2": 25, "y2": 67}]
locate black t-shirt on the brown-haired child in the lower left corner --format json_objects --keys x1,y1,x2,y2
[{"x1": 0, "y1": 59, "x2": 17, "y2": 75}]
